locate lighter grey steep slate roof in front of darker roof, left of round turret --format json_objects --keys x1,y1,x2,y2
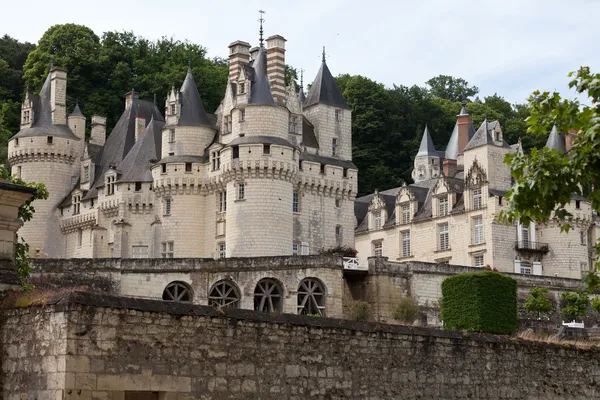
[{"x1": 117, "y1": 119, "x2": 165, "y2": 182}]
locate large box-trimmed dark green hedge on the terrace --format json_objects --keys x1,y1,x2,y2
[{"x1": 442, "y1": 271, "x2": 517, "y2": 334}]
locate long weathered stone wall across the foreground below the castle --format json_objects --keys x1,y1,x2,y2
[{"x1": 1, "y1": 294, "x2": 600, "y2": 400}]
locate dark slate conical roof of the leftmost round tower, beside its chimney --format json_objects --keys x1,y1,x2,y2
[{"x1": 14, "y1": 73, "x2": 80, "y2": 140}]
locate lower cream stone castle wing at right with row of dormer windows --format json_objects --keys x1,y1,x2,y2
[{"x1": 355, "y1": 103, "x2": 600, "y2": 279}]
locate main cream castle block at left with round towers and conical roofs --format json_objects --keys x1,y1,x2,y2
[{"x1": 8, "y1": 32, "x2": 357, "y2": 259}]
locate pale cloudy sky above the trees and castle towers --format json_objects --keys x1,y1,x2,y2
[{"x1": 0, "y1": 0, "x2": 600, "y2": 102}]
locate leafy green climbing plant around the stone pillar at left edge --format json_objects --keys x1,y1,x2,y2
[{"x1": 0, "y1": 165, "x2": 48, "y2": 289}]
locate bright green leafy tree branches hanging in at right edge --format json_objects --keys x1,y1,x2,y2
[{"x1": 499, "y1": 67, "x2": 600, "y2": 289}]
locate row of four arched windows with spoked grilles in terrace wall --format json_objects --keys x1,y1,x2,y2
[{"x1": 163, "y1": 278, "x2": 325, "y2": 316}]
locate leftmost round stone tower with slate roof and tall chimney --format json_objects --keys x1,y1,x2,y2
[{"x1": 8, "y1": 68, "x2": 85, "y2": 257}]
